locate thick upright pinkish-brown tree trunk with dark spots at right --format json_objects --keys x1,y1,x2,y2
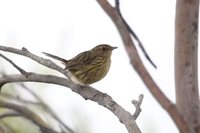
[{"x1": 175, "y1": 0, "x2": 200, "y2": 133}]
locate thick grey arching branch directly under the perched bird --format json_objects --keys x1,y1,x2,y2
[{"x1": 0, "y1": 73, "x2": 140, "y2": 133}]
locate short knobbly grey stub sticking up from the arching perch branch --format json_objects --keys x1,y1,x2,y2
[{"x1": 132, "y1": 94, "x2": 144, "y2": 120}]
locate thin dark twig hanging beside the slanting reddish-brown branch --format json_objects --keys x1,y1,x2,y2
[{"x1": 115, "y1": 0, "x2": 157, "y2": 68}]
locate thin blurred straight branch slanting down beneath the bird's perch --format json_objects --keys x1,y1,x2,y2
[{"x1": 21, "y1": 83, "x2": 75, "y2": 133}]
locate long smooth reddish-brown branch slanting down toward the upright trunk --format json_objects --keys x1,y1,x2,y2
[{"x1": 97, "y1": 0, "x2": 189, "y2": 133}]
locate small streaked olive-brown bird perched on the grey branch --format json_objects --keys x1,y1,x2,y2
[{"x1": 43, "y1": 44, "x2": 117, "y2": 85}]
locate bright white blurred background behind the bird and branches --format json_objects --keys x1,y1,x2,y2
[{"x1": 0, "y1": 0, "x2": 178, "y2": 133}]
